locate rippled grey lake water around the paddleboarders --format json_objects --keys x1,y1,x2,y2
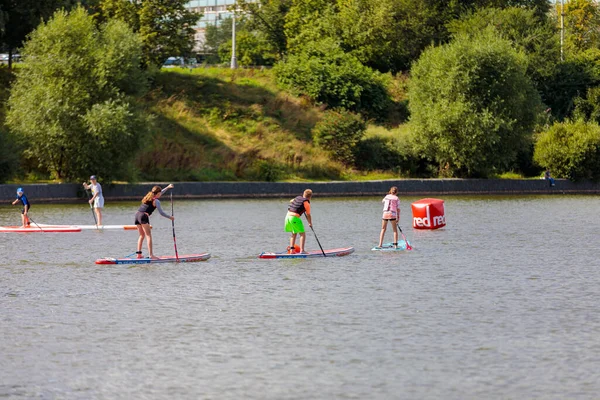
[{"x1": 0, "y1": 193, "x2": 600, "y2": 399}]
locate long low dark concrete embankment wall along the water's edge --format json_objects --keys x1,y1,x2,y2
[{"x1": 0, "y1": 179, "x2": 600, "y2": 204}]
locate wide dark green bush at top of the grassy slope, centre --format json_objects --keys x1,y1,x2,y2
[{"x1": 274, "y1": 39, "x2": 390, "y2": 119}]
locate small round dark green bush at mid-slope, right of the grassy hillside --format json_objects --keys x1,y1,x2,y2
[{"x1": 312, "y1": 110, "x2": 367, "y2": 165}]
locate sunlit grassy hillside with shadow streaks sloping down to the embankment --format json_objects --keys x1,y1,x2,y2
[{"x1": 135, "y1": 68, "x2": 400, "y2": 181}]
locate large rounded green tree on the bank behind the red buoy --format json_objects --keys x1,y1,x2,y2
[{"x1": 408, "y1": 29, "x2": 540, "y2": 177}]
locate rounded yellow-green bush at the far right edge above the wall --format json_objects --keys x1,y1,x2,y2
[{"x1": 533, "y1": 120, "x2": 600, "y2": 181}]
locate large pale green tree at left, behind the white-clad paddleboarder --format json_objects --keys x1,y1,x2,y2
[{"x1": 7, "y1": 8, "x2": 146, "y2": 180}]
